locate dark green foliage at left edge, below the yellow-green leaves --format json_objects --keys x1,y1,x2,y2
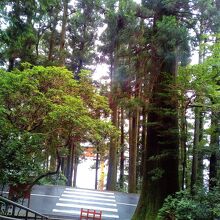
[{"x1": 0, "y1": 132, "x2": 44, "y2": 184}]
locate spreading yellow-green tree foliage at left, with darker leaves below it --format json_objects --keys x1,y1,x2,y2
[{"x1": 0, "y1": 63, "x2": 113, "y2": 186}]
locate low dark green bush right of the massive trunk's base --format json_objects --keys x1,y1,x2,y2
[{"x1": 158, "y1": 188, "x2": 220, "y2": 220}]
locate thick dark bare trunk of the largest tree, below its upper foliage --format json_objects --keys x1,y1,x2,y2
[{"x1": 132, "y1": 57, "x2": 179, "y2": 220}]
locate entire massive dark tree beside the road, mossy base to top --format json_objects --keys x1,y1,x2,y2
[{"x1": 132, "y1": 0, "x2": 187, "y2": 220}]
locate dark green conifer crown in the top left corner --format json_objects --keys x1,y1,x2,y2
[{"x1": 0, "y1": 0, "x2": 37, "y2": 71}]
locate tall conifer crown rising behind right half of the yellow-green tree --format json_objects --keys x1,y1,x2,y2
[{"x1": 67, "y1": 0, "x2": 102, "y2": 78}]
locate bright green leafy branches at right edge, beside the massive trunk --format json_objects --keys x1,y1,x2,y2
[{"x1": 177, "y1": 40, "x2": 220, "y2": 111}]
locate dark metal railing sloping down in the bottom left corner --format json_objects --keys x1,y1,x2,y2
[{"x1": 0, "y1": 196, "x2": 49, "y2": 220}]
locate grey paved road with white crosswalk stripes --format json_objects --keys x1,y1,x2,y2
[{"x1": 3, "y1": 186, "x2": 139, "y2": 220}]
